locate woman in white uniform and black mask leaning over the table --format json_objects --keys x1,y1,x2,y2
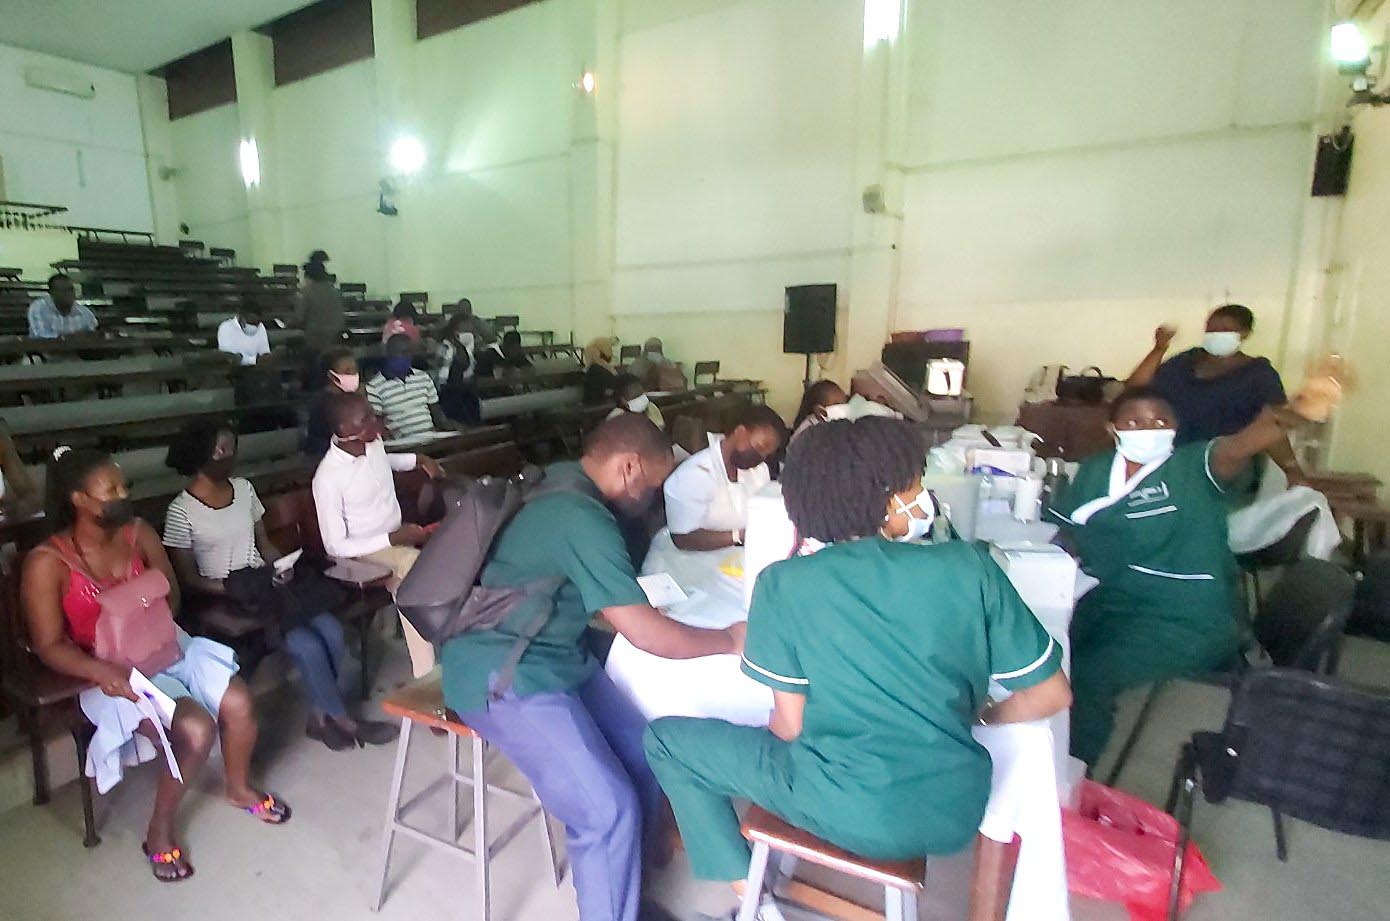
[{"x1": 666, "y1": 406, "x2": 787, "y2": 550}]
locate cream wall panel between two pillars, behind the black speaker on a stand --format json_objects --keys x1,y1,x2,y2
[{"x1": 613, "y1": 0, "x2": 862, "y2": 410}]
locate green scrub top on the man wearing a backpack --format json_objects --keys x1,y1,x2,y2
[{"x1": 439, "y1": 464, "x2": 646, "y2": 713}]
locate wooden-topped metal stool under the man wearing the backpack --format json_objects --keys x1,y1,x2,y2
[{"x1": 371, "y1": 678, "x2": 560, "y2": 921}]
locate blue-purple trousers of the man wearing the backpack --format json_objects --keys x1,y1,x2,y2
[{"x1": 459, "y1": 670, "x2": 662, "y2": 921}]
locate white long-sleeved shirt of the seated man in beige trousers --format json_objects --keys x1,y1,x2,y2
[{"x1": 314, "y1": 438, "x2": 416, "y2": 557}]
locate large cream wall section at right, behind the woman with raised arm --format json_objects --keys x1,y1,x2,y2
[{"x1": 894, "y1": 0, "x2": 1325, "y2": 417}]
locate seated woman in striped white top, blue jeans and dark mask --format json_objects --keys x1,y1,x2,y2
[{"x1": 164, "y1": 422, "x2": 398, "y2": 752}]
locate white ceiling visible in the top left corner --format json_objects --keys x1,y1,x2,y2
[{"x1": 0, "y1": 0, "x2": 309, "y2": 74}]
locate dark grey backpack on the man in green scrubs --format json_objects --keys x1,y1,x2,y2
[{"x1": 396, "y1": 467, "x2": 602, "y2": 700}]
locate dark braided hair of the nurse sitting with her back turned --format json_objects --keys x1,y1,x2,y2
[{"x1": 781, "y1": 417, "x2": 926, "y2": 543}]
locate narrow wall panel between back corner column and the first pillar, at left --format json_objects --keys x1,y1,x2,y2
[{"x1": 170, "y1": 104, "x2": 250, "y2": 261}]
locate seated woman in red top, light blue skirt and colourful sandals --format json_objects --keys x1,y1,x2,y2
[{"x1": 22, "y1": 447, "x2": 291, "y2": 882}]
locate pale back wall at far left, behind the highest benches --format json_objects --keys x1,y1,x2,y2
[{"x1": 0, "y1": 44, "x2": 154, "y2": 231}]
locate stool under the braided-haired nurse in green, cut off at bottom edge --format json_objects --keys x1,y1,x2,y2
[{"x1": 738, "y1": 806, "x2": 927, "y2": 921}]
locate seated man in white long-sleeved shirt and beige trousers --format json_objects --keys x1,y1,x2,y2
[{"x1": 314, "y1": 393, "x2": 443, "y2": 678}]
